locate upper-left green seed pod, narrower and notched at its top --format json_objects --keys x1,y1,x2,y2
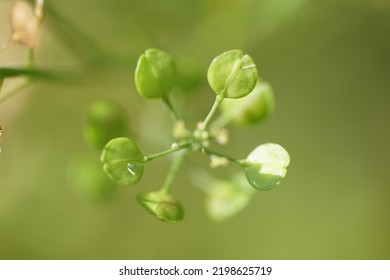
[{"x1": 135, "y1": 49, "x2": 177, "y2": 98}]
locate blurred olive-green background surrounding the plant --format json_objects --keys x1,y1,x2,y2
[{"x1": 0, "y1": 0, "x2": 390, "y2": 259}]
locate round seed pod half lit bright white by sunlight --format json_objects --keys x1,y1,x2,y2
[{"x1": 245, "y1": 143, "x2": 290, "y2": 191}]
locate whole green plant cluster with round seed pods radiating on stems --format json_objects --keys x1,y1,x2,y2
[{"x1": 91, "y1": 49, "x2": 290, "y2": 223}]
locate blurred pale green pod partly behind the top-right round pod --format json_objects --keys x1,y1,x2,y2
[{"x1": 220, "y1": 82, "x2": 275, "y2": 126}]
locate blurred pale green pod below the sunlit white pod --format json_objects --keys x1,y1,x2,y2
[{"x1": 205, "y1": 175, "x2": 254, "y2": 222}]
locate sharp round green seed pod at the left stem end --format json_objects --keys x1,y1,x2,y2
[{"x1": 101, "y1": 137, "x2": 144, "y2": 185}]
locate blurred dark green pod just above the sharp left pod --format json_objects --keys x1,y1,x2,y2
[{"x1": 84, "y1": 100, "x2": 129, "y2": 150}]
